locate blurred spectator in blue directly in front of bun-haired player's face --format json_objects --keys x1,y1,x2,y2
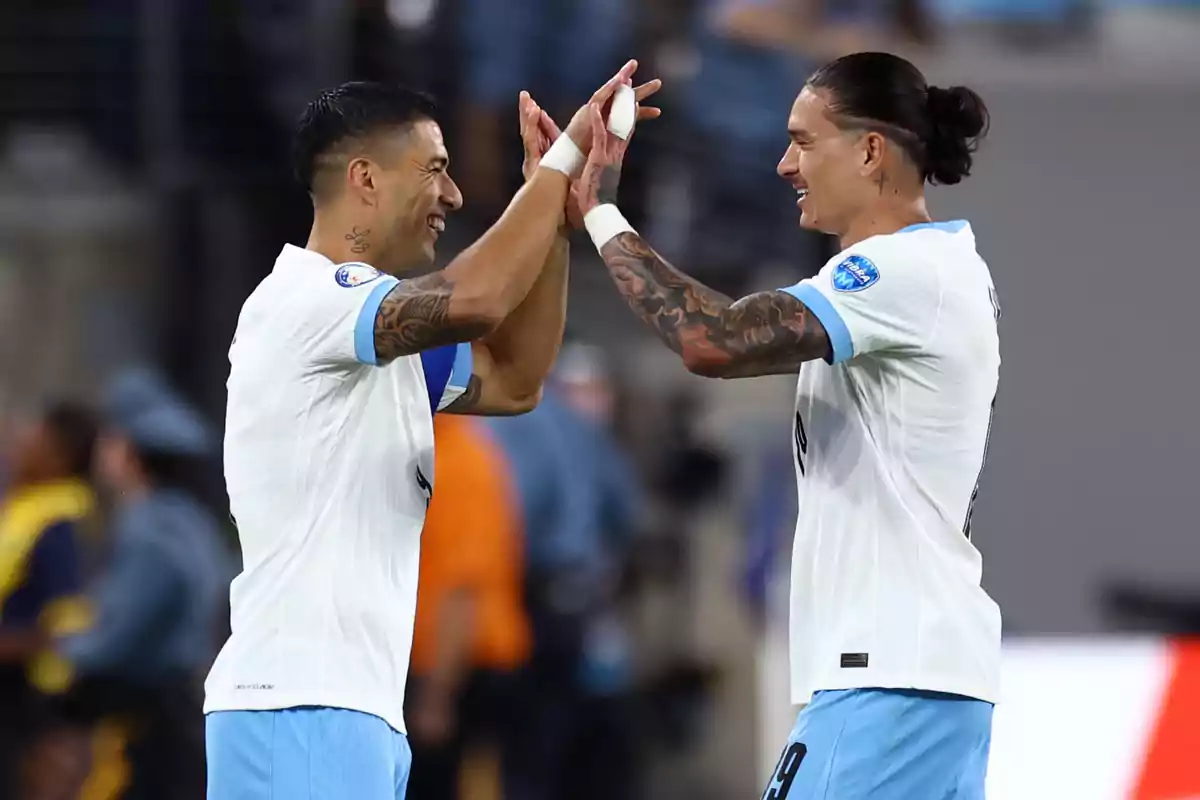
[{"x1": 685, "y1": 0, "x2": 924, "y2": 295}]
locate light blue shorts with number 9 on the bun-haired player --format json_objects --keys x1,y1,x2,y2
[{"x1": 762, "y1": 688, "x2": 992, "y2": 800}]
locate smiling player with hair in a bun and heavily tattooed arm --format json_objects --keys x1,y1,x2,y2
[{"x1": 577, "y1": 53, "x2": 1000, "y2": 800}]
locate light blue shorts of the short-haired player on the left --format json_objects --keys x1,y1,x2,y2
[{"x1": 204, "y1": 708, "x2": 413, "y2": 800}]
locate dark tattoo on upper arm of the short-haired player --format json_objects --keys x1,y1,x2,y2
[{"x1": 374, "y1": 272, "x2": 491, "y2": 362}]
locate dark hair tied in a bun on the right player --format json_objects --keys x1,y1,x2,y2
[{"x1": 809, "y1": 53, "x2": 990, "y2": 184}]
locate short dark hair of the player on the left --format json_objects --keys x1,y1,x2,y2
[{"x1": 292, "y1": 82, "x2": 437, "y2": 193}]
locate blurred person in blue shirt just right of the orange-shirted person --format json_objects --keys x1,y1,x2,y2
[{"x1": 491, "y1": 344, "x2": 643, "y2": 800}]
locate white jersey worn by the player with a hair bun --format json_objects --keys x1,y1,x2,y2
[{"x1": 785, "y1": 222, "x2": 1001, "y2": 703}]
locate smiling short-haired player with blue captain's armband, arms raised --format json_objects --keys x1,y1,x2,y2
[{"x1": 205, "y1": 61, "x2": 659, "y2": 800}]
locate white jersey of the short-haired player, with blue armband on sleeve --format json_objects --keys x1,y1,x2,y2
[{"x1": 204, "y1": 245, "x2": 470, "y2": 733}]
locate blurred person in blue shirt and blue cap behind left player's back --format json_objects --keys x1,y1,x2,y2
[{"x1": 50, "y1": 372, "x2": 229, "y2": 800}]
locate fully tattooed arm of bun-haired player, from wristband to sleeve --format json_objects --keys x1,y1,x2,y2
[{"x1": 600, "y1": 233, "x2": 830, "y2": 378}]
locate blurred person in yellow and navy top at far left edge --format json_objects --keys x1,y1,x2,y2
[{"x1": 0, "y1": 403, "x2": 95, "y2": 798}]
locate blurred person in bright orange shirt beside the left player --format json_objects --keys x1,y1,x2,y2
[{"x1": 406, "y1": 415, "x2": 530, "y2": 800}]
